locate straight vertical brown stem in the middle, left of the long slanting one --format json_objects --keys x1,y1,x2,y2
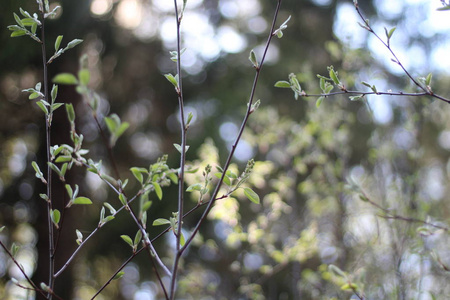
[{"x1": 169, "y1": 0, "x2": 187, "y2": 299}]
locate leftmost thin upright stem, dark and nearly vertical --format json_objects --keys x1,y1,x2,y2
[{"x1": 41, "y1": 10, "x2": 55, "y2": 300}]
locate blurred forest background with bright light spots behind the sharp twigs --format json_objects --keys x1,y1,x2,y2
[{"x1": 0, "y1": 0, "x2": 450, "y2": 299}]
